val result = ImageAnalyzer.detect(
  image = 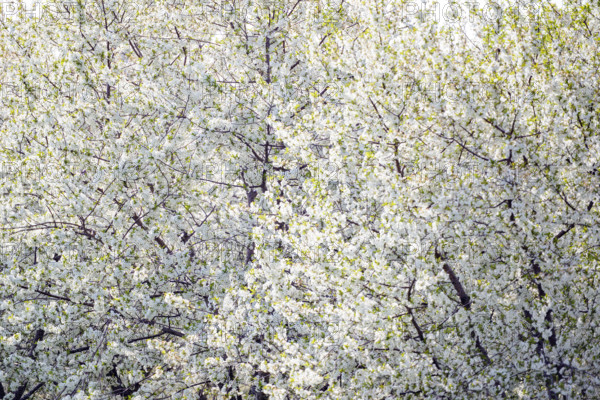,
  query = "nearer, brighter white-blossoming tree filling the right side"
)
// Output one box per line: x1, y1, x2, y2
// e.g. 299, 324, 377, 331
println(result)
224, 3, 599, 399
